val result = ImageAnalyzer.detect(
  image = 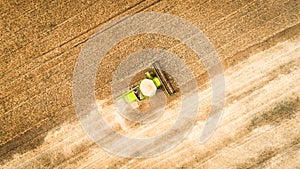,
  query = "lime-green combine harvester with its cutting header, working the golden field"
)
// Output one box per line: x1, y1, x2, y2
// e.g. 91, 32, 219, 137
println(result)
118, 61, 176, 103
